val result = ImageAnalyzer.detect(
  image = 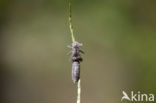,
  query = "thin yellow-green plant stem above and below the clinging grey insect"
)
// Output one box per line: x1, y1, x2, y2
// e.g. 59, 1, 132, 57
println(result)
69, 3, 81, 103
